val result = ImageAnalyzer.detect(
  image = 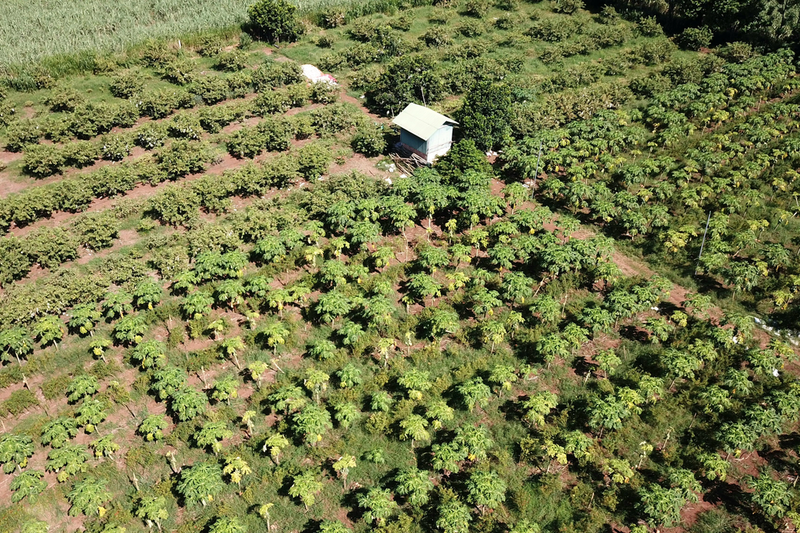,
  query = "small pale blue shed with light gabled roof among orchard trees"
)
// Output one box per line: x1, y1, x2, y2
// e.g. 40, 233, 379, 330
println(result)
392, 104, 458, 163
